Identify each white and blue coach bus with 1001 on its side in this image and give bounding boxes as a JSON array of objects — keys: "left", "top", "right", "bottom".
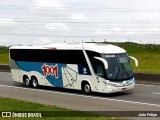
[{"left": 10, "top": 43, "right": 138, "bottom": 94}]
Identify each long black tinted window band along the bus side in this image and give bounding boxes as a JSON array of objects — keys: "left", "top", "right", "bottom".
[{"left": 10, "top": 49, "right": 88, "bottom": 67}]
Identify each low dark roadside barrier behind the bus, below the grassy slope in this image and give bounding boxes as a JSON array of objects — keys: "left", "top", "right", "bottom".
[{"left": 0, "top": 65, "right": 160, "bottom": 85}]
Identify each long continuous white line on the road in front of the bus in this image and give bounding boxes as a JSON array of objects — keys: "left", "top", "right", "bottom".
[{"left": 0, "top": 85, "right": 160, "bottom": 107}]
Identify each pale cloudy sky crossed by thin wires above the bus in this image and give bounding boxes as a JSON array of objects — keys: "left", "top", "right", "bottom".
[{"left": 0, "top": 0, "right": 160, "bottom": 46}]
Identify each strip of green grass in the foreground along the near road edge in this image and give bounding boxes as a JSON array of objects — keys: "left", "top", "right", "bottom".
[{"left": 0, "top": 98, "right": 119, "bottom": 120}]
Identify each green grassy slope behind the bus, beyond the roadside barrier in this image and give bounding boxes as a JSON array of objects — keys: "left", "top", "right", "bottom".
[{"left": 0, "top": 42, "right": 160, "bottom": 73}]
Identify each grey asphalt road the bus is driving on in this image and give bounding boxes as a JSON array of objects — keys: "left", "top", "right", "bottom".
[{"left": 0, "top": 72, "right": 160, "bottom": 120}]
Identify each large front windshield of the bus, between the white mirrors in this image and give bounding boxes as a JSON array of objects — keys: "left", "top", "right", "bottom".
[{"left": 102, "top": 53, "right": 133, "bottom": 81}]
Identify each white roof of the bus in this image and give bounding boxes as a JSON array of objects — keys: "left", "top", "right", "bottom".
[{"left": 10, "top": 43, "right": 126, "bottom": 54}]
